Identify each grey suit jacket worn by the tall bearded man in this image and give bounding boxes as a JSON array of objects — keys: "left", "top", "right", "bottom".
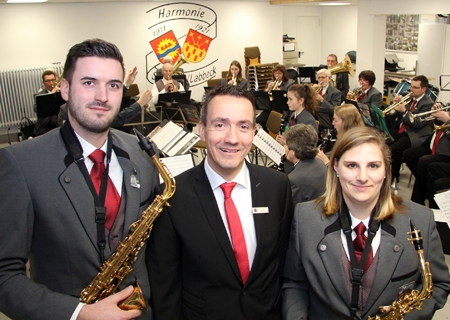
[{"left": 0, "top": 129, "right": 157, "bottom": 320}]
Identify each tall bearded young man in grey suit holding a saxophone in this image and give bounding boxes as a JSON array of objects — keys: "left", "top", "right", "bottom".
[{"left": 0, "top": 39, "right": 158, "bottom": 320}]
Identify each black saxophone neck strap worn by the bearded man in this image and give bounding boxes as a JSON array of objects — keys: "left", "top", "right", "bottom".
[{"left": 60, "top": 120, "right": 112, "bottom": 263}]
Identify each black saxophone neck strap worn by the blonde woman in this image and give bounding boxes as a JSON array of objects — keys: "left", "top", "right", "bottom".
[{"left": 339, "top": 201, "right": 380, "bottom": 320}]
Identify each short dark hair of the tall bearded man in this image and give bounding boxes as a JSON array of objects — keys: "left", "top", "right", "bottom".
[{"left": 63, "top": 39, "right": 125, "bottom": 83}]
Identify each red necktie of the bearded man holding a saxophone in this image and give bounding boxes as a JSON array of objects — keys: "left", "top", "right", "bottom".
[{"left": 89, "top": 149, "right": 120, "bottom": 230}]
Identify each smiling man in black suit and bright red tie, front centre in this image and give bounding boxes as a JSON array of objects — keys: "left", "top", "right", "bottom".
[{"left": 147, "top": 86, "right": 293, "bottom": 320}]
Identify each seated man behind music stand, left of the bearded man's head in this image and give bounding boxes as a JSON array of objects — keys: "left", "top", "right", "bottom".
[{"left": 33, "top": 69, "right": 59, "bottom": 136}]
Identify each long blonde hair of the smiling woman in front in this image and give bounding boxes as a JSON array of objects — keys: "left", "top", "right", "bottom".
[{"left": 316, "top": 127, "right": 404, "bottom": 221}]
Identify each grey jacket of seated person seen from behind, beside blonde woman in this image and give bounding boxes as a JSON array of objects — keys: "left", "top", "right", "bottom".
[{"left": 288, "top": 158, "right": 327, "bottom": 204}]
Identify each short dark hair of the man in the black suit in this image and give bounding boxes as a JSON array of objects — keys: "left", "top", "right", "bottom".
[{"left": 200, "top": 84, "right": 256, "bottom": 125}]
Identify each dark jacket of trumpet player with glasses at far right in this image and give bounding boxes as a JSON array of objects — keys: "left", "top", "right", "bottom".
[{"left": 398, "top": 95, "right": 434, "bottom": 147}]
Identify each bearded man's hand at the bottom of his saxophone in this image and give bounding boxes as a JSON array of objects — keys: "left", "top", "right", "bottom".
[{"left": 77, "top": 286, "right": 142, "bottom": 320}]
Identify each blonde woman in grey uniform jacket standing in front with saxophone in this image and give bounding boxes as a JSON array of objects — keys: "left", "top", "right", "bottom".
[{"left": 282, "top": 126, "right": 450, "bottom": 320}]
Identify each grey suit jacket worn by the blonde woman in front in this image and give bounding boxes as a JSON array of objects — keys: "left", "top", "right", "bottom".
[{"left": 283, "top": 201, "right": 450, "bottom": 320}]
